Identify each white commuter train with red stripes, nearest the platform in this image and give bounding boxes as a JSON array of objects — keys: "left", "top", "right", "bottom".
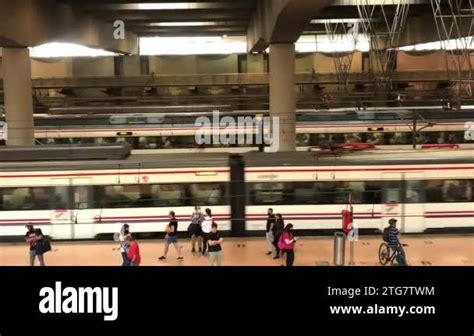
[{"left": 0, "top": 150, "right": 474, "bottom": 239}]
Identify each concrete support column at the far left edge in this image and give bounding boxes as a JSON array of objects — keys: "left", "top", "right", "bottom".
[{"left": 3, "top": 48, "right": 35, "bottom": 146}]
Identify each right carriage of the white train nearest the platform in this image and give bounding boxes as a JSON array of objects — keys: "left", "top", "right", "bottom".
[{"left": 246, "top": 151, "right": 474, "bottom": 232}]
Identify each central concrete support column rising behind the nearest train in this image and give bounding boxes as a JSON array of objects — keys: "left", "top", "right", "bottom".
[{"left": 270, "top": 43, "right": 296, "bottom": 152}]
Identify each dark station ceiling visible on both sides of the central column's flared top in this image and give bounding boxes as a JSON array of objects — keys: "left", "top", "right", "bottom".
[{"left": 61, "top": 0, "right": 438, "bottom": 36}]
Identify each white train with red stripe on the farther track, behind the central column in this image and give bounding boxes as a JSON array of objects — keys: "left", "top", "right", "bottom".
[{"left": 5, "top": 105, "right": 474, "bottom": 154}]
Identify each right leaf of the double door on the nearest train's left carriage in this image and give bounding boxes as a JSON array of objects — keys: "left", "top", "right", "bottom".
[{"left": 71, "top": 178, "right": 97, "bottom": 239}]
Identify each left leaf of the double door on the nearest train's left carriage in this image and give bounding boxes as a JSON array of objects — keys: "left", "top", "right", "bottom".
[{"left": 50, "top": 179, "right": 74, "bottom": 239}]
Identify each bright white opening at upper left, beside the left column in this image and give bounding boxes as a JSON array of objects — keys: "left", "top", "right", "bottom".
[{"left": 30, "top": 42, "right": 118, "bottom": 58}]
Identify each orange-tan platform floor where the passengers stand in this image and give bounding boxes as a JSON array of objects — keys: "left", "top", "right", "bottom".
[{"left": 0, "top": 234, "right": 474, "bottom": 266}]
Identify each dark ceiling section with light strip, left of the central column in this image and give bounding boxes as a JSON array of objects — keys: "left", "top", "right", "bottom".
[{"left": 63, "top": 0, "right": 257, "bottom": 37}]
